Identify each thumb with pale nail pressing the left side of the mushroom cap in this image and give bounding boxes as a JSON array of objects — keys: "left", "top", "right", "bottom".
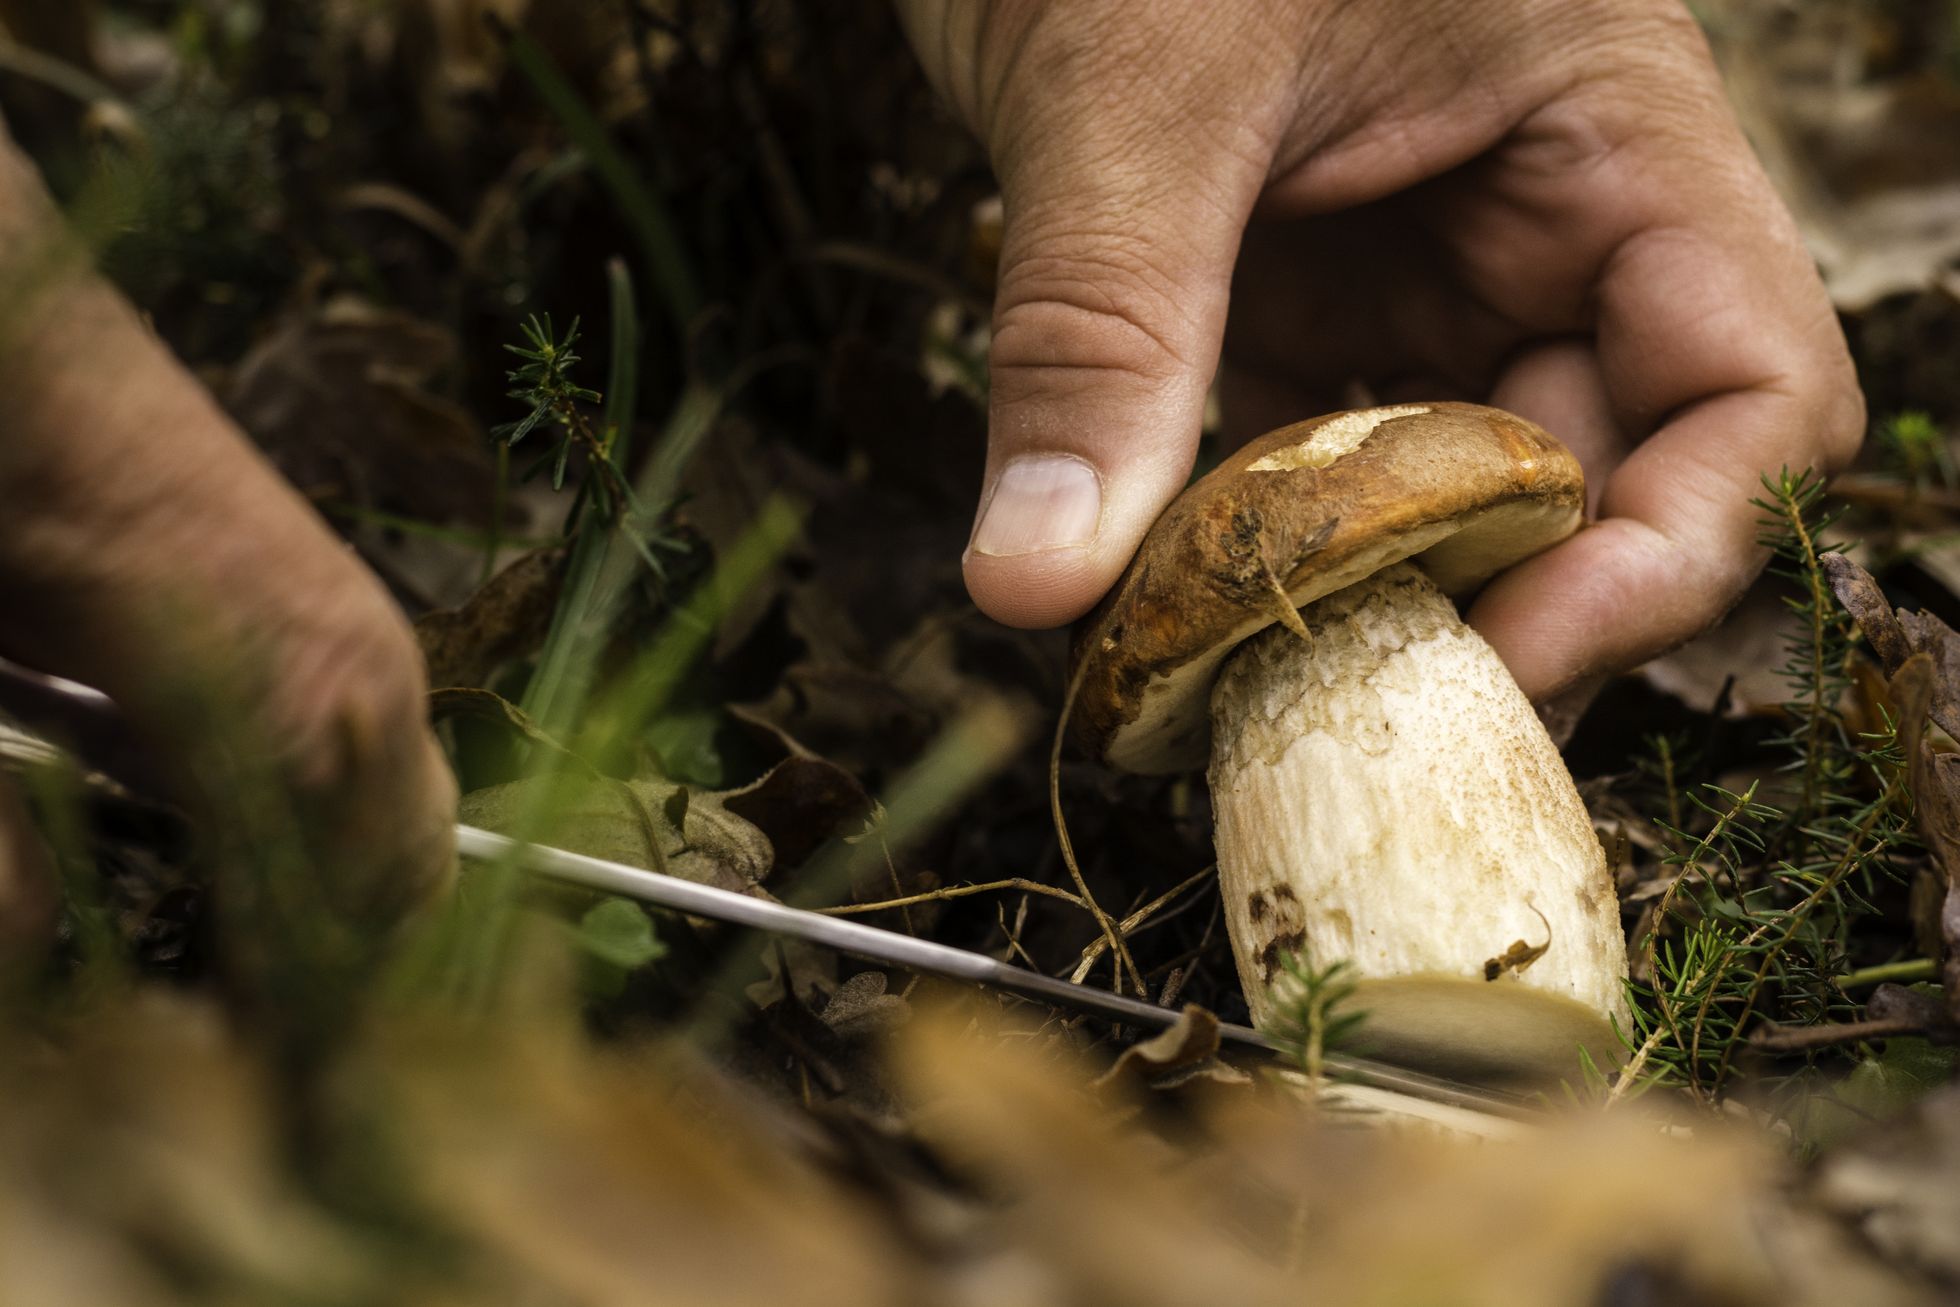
[{"left": 964, "top": 43, "right": 1270, "bottom": 627}]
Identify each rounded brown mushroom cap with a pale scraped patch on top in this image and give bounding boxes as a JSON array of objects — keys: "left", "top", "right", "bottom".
[{"left": 1070, "top": 404, "right": 1586, "bottom": 774}]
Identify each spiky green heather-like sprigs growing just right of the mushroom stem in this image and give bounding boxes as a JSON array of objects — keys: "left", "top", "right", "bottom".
[{"left": 1611, "top": 472, "right": 1917, "bottom": 1103}]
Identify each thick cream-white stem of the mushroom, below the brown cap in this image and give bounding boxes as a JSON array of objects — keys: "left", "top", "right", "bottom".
[{"left": 1211, "top": 564, "right": 1627, "bottom": 1066}]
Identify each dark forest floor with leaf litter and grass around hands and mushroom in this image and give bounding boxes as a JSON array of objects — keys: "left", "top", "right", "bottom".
[{"left": 0, "top": 0, "right": 1960, "bottom": 1307}]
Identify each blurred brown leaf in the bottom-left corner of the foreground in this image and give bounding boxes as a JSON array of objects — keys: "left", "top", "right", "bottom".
[{"left": 0, "top": 993, "right": 380, "bottom": 1307}]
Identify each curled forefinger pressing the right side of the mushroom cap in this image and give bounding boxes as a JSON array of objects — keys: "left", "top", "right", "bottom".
[{"left": 1470, "top": 12, "right": 1864, "bottom": 698}]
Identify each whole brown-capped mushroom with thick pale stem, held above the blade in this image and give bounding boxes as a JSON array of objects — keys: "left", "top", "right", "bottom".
[{"left": 1070, "top": 404, "right": 1627, "bottom": 1082}]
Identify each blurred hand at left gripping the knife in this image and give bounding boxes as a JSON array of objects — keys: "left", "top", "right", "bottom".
[{"left": 0, "top": 135, "right": 455, "bottom": 917}]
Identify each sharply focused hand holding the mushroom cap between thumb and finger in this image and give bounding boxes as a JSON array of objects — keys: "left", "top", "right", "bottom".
[{"left": 898, "top": 0, "right": 1864, "bottom": 700}]
